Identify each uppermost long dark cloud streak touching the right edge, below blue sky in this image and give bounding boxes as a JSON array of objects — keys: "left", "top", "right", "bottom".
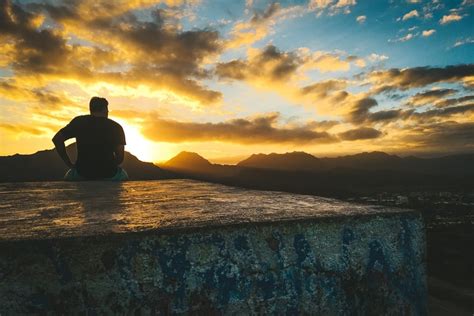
[{"left": 369, "top": 64, "right": 474, "bottom": 92}]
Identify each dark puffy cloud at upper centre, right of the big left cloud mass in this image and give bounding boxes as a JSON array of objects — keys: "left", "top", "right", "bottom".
[{"left": 216, "top": 45, "right": 301, "bottom": 81}]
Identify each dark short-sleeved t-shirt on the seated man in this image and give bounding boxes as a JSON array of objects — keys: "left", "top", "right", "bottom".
[{"left": 61, "top": 115, "right": 125, "bottom": 179}]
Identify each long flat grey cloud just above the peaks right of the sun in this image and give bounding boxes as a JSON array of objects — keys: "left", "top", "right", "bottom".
[{"left": 142, "top": 113, "right": 337, "bottom": 144}]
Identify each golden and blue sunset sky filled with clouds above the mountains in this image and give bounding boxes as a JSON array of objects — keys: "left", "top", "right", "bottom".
[{"left": 0, "top": 0, "right": 474, "bottom": 163}]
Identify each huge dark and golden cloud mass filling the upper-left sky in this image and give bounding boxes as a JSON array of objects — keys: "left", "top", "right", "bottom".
[{"left": 0, "top": 1, "right": 222, "bottom": 105}]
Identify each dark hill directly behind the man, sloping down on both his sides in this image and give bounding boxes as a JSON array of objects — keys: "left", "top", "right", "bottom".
[{"left": 0, "top": 143, "right": 176, "bottom": 182}]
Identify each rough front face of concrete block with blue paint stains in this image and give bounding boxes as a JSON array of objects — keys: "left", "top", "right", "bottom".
[{"left": 0, "top": 212, "right": 426, "bottom": 315}]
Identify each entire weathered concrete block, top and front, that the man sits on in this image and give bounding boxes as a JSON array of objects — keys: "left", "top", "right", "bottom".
[{"left": 0, "top": 180, "right": 426, "bottom": 315}]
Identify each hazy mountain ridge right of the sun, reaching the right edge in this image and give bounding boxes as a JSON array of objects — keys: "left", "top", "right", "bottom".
[{"left": 160, "top": 152, "right": 474, "bottom": 197}]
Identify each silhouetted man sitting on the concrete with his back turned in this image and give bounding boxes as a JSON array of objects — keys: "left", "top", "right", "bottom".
[{"left": 53, "top": 97, "right": 128, "bottom": 181}]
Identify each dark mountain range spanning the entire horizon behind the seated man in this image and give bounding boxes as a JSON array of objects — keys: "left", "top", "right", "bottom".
[{"left": 0, "top": 144, "right": 474, "bottom": 197}]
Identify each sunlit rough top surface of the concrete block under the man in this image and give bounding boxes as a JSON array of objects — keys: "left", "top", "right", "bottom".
[{"left": 0, "top": 180, "right": 412, "bottom": 241}]
